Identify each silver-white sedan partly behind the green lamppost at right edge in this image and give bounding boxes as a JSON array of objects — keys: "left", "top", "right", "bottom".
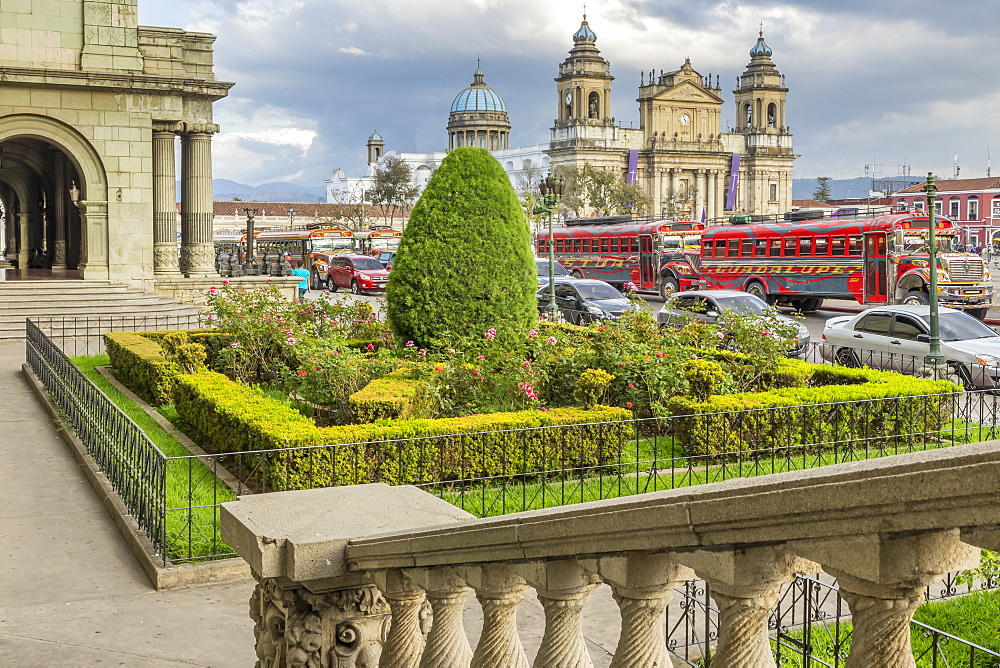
[{"left": 822, "top": 305, "right": 1000, "bottom": 390}]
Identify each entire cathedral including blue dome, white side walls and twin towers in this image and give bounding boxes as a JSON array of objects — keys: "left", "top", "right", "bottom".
[{"left": 327, "top": 15, "right": 797, "bottom": 220}]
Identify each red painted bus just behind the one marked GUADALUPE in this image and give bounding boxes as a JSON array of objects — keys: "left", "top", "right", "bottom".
[{"left": 536, "top": 216, "right": 705, "bottom": 298}]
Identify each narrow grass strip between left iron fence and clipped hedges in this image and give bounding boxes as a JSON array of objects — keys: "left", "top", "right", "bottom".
[{"left": 73, "top": 355, "right": 236, "bottom": 561}]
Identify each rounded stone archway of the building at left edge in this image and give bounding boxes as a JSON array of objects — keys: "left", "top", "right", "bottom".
[{"left": 0, "top": 114, "right": 109, "bottom": 280}]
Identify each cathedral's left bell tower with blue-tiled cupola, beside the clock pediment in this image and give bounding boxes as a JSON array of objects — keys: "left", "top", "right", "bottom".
[{"left": 556, "top": 14, "right": 614, "bottom": 126}]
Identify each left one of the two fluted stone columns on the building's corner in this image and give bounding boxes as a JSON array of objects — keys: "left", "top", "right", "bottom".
[{"left": 153, "top": 126, "right": 182, "bottom": 276}]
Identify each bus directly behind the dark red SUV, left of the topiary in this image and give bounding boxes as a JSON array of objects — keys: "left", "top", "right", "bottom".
[{"left": 254, "top": 227, "right": 354, "bottom": 290}]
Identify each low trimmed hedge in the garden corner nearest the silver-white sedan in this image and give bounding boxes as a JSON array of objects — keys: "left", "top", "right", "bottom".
[{"left": 659, "top": 365, "right": 960, "bottom": 455}]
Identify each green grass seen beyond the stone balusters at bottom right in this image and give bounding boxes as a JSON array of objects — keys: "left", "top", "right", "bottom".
[{"left": 771, "top": 591, "right": 1000, "bottom": 668}]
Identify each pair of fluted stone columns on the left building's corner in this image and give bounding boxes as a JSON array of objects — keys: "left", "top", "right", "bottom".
[{"left": 153, "top": 122, "right": 219, "bottom": 277}]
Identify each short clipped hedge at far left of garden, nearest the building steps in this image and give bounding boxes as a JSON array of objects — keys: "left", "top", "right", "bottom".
[{"left": 104, "top": 332, "right": 180, "bottom": 405}]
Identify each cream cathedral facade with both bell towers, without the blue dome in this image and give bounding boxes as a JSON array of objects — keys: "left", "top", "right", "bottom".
[{"left": 548, "top": 16, "right": 797, "bottom": 219}]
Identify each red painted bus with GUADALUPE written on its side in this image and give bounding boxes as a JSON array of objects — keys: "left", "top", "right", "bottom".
[{"left": 694, "top": 213, "right": 993, "bottom": 319}]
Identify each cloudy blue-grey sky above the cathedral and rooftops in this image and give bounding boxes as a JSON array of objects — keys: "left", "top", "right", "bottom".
[{"left": 139, "top": 0, "right": 1000, "bottom": 186}]
